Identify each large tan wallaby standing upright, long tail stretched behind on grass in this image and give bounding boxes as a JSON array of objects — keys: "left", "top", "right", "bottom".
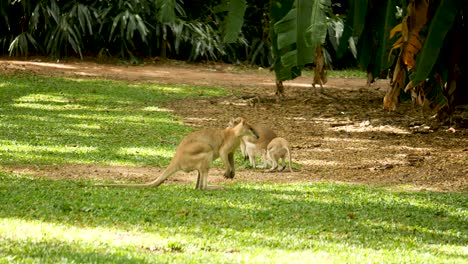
[{"left": 98, "top": 118, "right": 258, "bottom": 190}]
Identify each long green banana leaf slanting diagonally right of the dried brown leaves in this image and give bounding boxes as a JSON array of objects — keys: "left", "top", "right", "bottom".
[{"left": 410, "top": 0, "right": 466, "bottom": 86}]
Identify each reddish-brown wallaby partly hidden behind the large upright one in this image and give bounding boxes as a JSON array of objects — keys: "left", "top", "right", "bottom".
[{"left": 229, "top": 119, "right": 276, "bottom": 169}]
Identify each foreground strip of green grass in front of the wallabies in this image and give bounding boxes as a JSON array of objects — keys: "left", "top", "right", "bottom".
[{"left": 0, "top": 173, "right": 468, "bottom": 263}]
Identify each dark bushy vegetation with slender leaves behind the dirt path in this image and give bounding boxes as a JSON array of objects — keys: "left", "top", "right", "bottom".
[{"left": 0, "top": 0, "right": 356, "bottom": 68}]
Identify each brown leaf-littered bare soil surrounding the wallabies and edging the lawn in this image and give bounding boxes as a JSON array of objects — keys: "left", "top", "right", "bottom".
[{"left": 0, "top": 59, "right": 468, "bottom": 192}]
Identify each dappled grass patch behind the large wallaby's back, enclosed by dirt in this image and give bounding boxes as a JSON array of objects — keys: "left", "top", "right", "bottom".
[{"left": 0, "top": 74, "right": 226, "bottom": 166}]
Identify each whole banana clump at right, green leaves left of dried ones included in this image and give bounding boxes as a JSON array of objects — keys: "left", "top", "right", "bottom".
[{"left": 338, "top": 0, "right": 468, "bottom": 117}]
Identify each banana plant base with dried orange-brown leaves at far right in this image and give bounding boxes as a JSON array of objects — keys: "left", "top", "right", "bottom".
[{"left": 384, "top": 0, "right": 468, "bottom": 118}]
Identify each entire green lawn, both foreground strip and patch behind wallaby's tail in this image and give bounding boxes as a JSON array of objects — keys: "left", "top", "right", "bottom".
[{"left": 0, "top": 73, "right": 468, "bottom": 263}]
